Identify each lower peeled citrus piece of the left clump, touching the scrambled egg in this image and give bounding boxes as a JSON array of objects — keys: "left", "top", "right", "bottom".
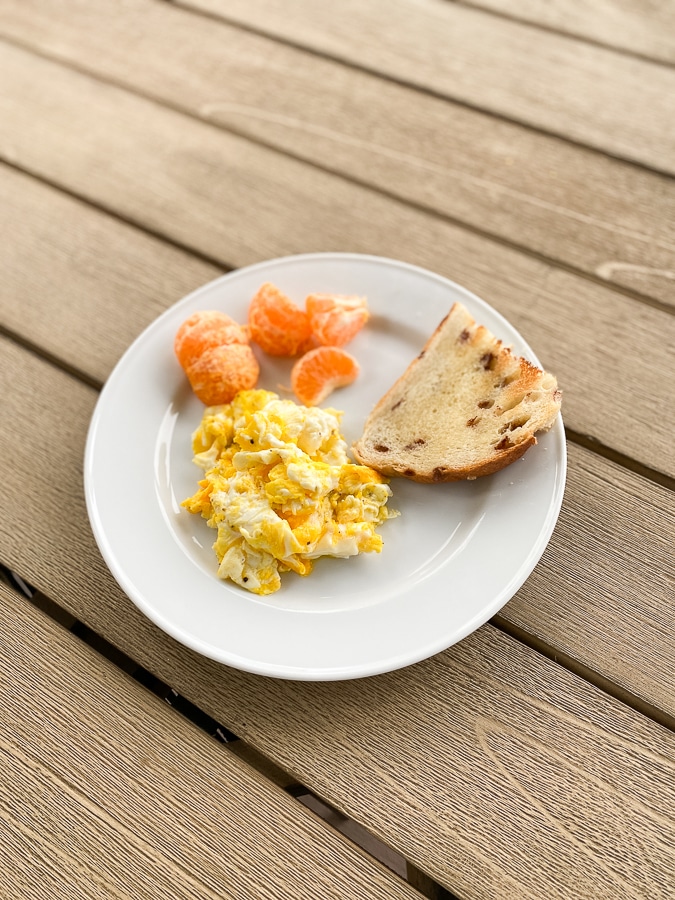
[{"left": 185, "top": 344, "right": 260, "bottom": 406}]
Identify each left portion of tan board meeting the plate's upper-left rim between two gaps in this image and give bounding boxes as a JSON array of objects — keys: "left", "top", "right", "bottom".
[{"left": 0, "top": 165, "right": 223, "bottom": 383}]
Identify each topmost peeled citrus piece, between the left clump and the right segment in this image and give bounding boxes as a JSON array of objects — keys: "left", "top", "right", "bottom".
[{"left": 248, "top": 282, "right": 312, "bottom": 356}]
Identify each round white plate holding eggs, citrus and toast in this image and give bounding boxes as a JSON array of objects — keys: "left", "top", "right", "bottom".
[{"left": 84, "top": 253, "right": 566, "bottom": 680}]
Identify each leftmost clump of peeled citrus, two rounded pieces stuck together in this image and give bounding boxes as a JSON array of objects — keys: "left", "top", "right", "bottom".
[{"left": 174, "top": 310, "right": 260, "bottom": 406}]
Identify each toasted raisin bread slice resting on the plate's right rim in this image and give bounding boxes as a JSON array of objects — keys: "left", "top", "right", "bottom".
[{"left": 352, "top": 303, "right": 561, "bottom": 482}]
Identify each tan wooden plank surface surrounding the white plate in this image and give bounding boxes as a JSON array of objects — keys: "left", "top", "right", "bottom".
[{"left": 0, "top": 0, "right": 675, "bottom": 900}]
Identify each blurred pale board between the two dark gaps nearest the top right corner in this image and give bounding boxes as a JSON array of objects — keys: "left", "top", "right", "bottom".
[{"left": 172, "top": 0, "right": 675, "bottom": 174}]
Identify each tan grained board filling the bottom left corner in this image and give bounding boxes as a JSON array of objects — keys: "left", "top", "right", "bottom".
[{"left": 0, "top": 585, "right": 420, "bottom": 900}]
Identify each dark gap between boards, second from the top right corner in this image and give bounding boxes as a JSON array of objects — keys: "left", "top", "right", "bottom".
[{"left": 165, "top": 0, "right": 674, "bottom": 178}]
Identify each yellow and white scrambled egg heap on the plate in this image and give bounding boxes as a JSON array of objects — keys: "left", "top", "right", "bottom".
[{"left": 183, "top": 390, "right": 398, "bottom": 594}]
